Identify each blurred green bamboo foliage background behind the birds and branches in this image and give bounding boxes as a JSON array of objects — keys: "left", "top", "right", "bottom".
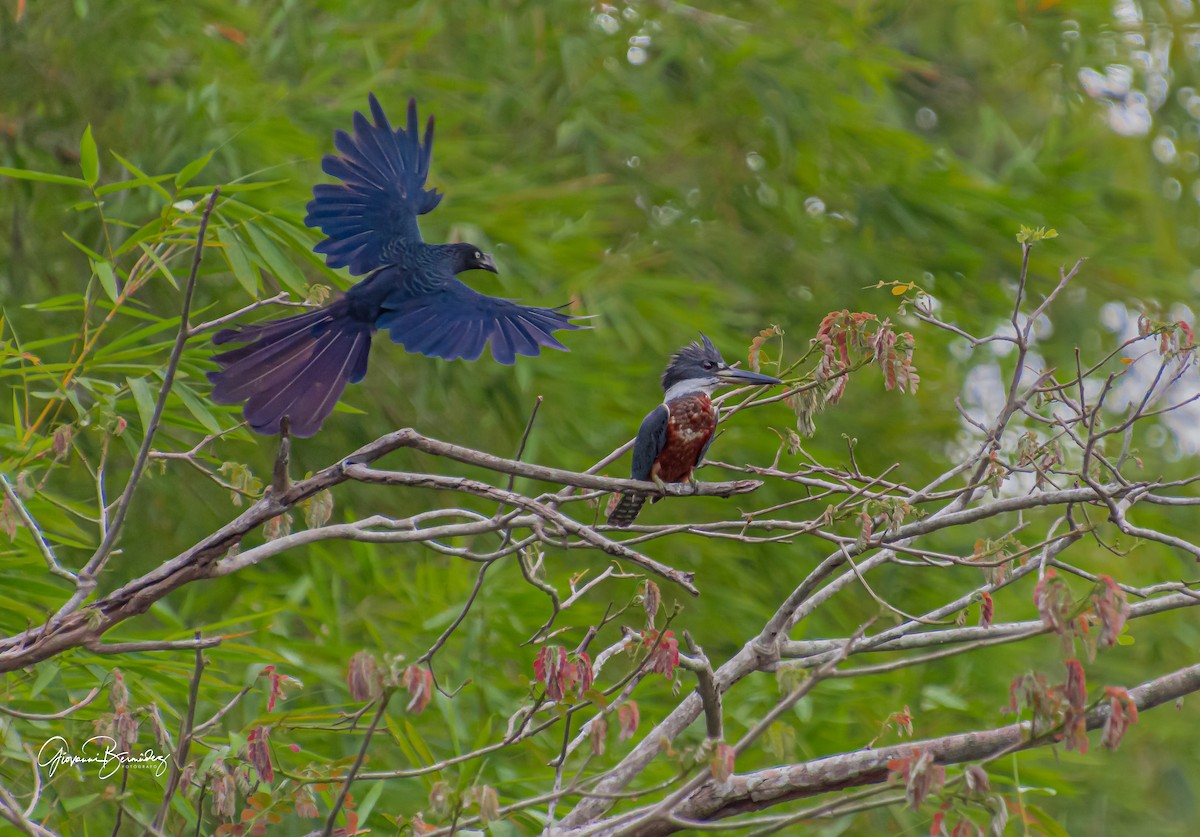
[{"left": 0, "top": 0, "right": 1200, "bottom": 835}]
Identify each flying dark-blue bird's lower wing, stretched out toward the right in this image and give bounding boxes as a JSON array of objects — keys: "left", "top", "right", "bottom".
[{"left": 376, "top": 279, "right": 583, "bottom": 363}]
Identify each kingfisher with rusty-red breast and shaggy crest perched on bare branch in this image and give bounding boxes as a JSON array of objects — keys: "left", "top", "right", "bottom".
[{"left": 608, "top": 332, "right": 784, "bottom": 526}]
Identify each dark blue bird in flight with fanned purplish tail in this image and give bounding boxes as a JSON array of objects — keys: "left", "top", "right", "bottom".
[{"left": 209, "top": 94, "right": 581, "bottom": 436}]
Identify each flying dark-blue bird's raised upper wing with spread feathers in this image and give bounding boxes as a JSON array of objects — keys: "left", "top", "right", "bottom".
[{"left": 304, "top": 94, "right": 442, "bottom": 276}]
